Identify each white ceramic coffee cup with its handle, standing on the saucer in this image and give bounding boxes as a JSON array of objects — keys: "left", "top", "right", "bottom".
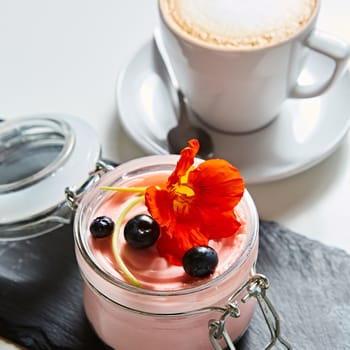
[{"left": 159, "top": 0, "right": 350, "bottom": 133}]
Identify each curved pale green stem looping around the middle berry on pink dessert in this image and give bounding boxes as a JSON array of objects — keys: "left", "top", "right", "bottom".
[{"left": 112, "top": 196, "right": 144, "bottom": 287}]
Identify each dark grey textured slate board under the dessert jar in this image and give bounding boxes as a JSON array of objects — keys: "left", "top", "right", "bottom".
[{"left": 0, "top": 222, "right": 350, "bottom": 350}]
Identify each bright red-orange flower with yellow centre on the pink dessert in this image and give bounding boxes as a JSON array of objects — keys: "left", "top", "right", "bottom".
[{"left": 145, "top": 140, "right": 244, "bottom": 265}]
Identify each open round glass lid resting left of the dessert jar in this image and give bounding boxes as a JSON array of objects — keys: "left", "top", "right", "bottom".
[{"left": 0, "top": 114, "right": 100, "bottom": 240}]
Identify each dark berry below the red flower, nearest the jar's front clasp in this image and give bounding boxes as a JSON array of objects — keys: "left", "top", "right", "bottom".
[{"left": 182, "top": 246, "right": 219, "bottom": 277}]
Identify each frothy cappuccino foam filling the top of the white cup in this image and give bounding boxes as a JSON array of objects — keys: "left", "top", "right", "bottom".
[{"left": 160, "top": 0, "right": 318, "bottom": 48}]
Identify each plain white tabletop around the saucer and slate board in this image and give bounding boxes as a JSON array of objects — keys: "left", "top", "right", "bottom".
[{"left": 0, "top": 0, "right": 350, "bottom": 349}]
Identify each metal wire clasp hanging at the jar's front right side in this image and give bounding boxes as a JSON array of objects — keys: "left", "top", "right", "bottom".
[{"left": 208, "top": 274, "right": 292, "bottom": 350}]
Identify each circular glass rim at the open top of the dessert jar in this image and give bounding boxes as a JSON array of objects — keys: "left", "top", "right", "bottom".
[{"left": 74, "top": 155, "right": 259, "bottom": 296}]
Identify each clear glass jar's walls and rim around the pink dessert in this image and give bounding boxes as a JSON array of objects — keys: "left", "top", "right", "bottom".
[{"left": 74, "top": 155, "right": 259, "bottom": 350}]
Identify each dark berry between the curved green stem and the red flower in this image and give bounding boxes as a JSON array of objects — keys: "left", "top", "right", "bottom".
[{"left": 124, "top": 214, "right": 160, "bottom": 249}]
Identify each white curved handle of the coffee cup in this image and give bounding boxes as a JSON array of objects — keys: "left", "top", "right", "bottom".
[{"left": 290, "top": 30, "right": 350, "bottom": 98}]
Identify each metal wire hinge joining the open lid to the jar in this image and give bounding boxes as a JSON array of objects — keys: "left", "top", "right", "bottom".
[{"left": 64, "top": 160, "right": 114, "bottom": 210}]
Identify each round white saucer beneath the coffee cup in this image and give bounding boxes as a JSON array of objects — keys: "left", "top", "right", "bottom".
[{"left": 116, "top": 41, "right": 350, "bottom": 184}]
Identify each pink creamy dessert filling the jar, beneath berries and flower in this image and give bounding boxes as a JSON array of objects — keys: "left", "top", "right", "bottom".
[{"left": 74, "top": 155, "right": 258, "bottom": 350}]
